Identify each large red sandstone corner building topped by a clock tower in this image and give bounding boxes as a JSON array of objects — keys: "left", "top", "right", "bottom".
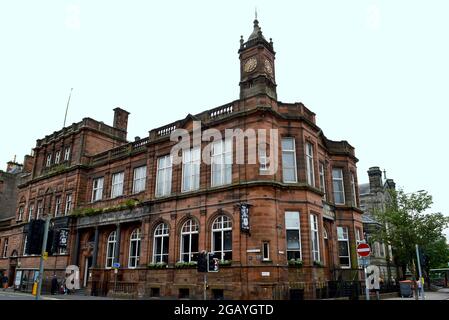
[{"left": 0, "top": 20, "right": 363, "bottom": 299}]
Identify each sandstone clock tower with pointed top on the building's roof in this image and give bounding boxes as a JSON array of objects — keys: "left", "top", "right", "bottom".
[{"left": 239, "top": 18, "right": 277, "bottom": 100}]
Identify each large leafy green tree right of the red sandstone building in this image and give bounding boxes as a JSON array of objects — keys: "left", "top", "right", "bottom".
[{"left": 373, "top": 190, "right": 449, "bottom": 282}]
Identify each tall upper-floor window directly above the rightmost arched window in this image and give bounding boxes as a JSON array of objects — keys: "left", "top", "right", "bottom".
[{"left": 211, "top": 139, "right": 232, "bottom": 187}]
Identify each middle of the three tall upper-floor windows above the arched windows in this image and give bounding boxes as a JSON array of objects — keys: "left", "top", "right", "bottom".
[{"left": 182, "top": 147, "right": 201, "bottom": 192}]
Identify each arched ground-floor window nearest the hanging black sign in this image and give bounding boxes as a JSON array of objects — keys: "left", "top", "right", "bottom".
[{"left": 212, "top": 216, "right": 232, "bottom": 260}]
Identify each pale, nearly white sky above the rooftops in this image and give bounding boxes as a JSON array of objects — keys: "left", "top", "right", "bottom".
[{"left": 0, "top": 0, "right": 449, "bottom": 239}]
